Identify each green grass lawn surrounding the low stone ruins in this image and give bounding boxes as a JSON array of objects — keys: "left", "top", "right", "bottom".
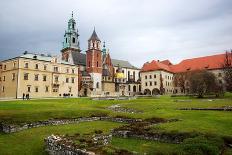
[{"left": 0, "top": 95, "right": 232, "bottom": 154}]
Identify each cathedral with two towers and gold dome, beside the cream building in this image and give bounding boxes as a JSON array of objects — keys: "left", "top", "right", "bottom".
[{"left": 61, "top": 15, "right": 141, "bottom": 96}]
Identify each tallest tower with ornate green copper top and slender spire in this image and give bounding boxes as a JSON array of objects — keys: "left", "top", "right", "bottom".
[{"left": 61, "top": 12, "right": 81, "bottom": 61}]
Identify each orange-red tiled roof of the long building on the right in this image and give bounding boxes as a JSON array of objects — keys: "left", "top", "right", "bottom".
[{"left": 142, "top": 54, "right": 225, "bottom": 73}]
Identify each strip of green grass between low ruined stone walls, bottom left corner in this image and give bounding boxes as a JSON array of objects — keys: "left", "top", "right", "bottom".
[{"left": 0, "top": 121, "right": 121, "bottom": 155}]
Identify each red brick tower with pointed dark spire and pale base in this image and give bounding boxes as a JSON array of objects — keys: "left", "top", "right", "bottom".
[{"left": 86, "top": 29, "right": 102, "bottom": 91}]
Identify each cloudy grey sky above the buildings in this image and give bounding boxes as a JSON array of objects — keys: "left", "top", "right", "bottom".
[{"left": 0, "top": 0, "right": 232, "bottom": 67}]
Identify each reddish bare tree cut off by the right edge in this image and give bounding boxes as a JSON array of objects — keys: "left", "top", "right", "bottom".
[{"left": 223, "top": 50, "right": 232, "bottom": 92}]
